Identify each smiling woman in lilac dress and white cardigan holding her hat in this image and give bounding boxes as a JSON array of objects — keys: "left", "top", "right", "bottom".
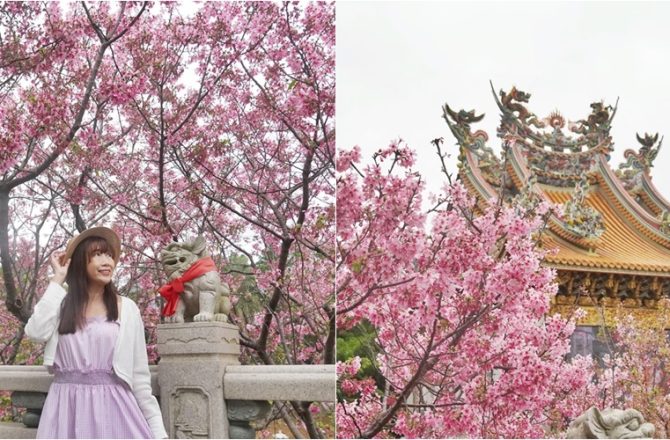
[{"left": 25, "top": 227, "right": 167, "bottom": 438}]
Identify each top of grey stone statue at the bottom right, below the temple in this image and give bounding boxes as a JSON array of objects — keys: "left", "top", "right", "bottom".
[{"left": 566, "top": 406, "right": 655, "bottom": 438}]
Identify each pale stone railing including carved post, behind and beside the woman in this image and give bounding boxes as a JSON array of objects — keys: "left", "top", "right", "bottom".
[{"left": 0, "top": 322, "right": 336, "bottom": 438}]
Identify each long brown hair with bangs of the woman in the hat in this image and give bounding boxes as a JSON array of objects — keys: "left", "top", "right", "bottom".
[{"left": 58, "top": 237, "right": 119, "bottom": 335}]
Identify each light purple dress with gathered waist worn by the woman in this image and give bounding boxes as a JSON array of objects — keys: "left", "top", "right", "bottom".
[{"left": 37, "top": 316, "right": 152, "bottom": 438}]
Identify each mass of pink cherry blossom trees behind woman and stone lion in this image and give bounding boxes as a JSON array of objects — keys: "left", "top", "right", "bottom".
[{"left": 0, "top": 3, "right": 335, "bottom": 437}]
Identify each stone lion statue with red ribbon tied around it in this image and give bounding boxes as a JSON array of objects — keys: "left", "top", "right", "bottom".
[{"left": 160, "top": 236, "right": 230, "bottom": 323}]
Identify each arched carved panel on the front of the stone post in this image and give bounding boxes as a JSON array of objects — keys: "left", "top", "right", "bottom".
[{"left": 171, "top": 388, "right": 209, "bottom": 438}]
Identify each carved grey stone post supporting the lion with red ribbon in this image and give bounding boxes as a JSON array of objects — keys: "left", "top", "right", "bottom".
[{"left": 157, "top": 321, "right": 240, "bottom": 438}]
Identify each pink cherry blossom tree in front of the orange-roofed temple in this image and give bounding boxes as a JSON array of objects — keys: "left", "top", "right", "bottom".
[{"left": 336, "top": 141, "right": 592, "bottom": 438}]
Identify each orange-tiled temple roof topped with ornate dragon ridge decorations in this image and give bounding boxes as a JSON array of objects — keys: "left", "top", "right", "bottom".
[{"left": 444, "top": 85, "right": 670, "bottom": 277}]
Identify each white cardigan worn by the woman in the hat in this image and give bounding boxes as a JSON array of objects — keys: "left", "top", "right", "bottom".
[{"left": 25, "top": 282, "right": 167, "bottom": 438}]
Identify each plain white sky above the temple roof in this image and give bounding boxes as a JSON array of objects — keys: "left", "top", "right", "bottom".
[{"left": 337, "top": 2, "right": 670, "bottom": 200}]
